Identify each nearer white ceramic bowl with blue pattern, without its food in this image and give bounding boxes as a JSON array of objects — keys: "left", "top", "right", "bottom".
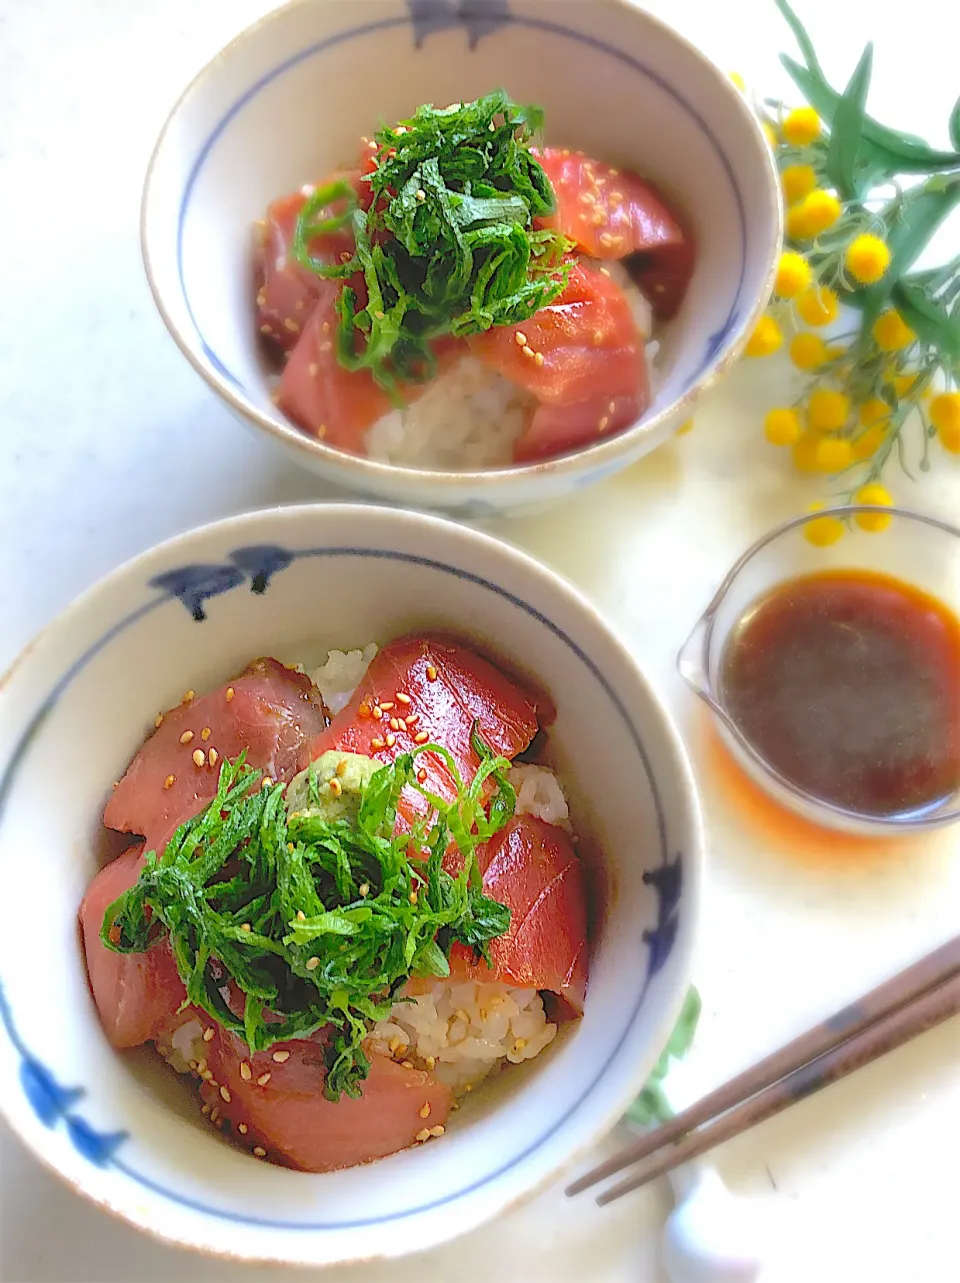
[{"left": 0, "top": 506, "right": 702, "bottom": 1264}]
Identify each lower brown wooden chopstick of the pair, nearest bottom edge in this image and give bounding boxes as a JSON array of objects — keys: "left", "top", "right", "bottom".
[{"left": 597, "top": 976, "right": 960, "bottom": 1207}]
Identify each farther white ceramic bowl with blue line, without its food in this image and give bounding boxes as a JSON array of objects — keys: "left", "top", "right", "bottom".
[{"left": 142, "top": 0, "right": 780, "bottom": 516}]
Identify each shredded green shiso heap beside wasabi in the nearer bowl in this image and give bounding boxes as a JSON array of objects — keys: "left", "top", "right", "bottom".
[{"left": 100, "top": 730, "right": 516, "bottom": 1101}]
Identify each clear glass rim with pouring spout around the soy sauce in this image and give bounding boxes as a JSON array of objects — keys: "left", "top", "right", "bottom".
[{"left": 676, "top": 503, "right": 960, "bottom": 838}]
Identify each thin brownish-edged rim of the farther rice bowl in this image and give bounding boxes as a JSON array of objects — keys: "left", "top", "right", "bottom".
[{"left": 140, "top": 0, "right": 783, "bottom": 487}]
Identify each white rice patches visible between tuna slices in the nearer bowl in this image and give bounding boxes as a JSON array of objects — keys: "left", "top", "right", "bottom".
[{"left": 164, "top": 643, "right": 569, "bottom": 1096}]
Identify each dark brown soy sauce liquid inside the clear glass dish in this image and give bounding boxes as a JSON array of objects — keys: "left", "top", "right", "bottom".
[{"left": 720, "top": 570, "right": 960, "bottom": 816}]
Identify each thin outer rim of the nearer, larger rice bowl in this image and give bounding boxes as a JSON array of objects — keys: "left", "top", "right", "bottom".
[{"left": 0, "top": 500, "right": 706, "bottom": 1268}]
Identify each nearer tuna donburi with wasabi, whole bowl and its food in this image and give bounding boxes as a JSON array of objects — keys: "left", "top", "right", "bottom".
[{"left": 0, "top": 504, "right": 702, "bottom": 1264}]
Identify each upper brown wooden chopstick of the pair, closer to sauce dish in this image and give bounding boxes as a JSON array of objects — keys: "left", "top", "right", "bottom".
[{"left": 567, "top": 935, "right": 960, "bottom": 1196}]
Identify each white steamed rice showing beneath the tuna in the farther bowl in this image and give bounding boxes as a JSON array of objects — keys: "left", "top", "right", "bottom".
[{"left": 366, "top": 268, "right": 660, "bottom": 472}]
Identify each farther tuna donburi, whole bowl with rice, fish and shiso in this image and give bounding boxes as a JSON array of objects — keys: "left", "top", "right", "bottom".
[{"left": 142, "top": 0, "right": 780, "bottom": 514}]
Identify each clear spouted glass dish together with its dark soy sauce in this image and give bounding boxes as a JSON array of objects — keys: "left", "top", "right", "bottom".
[{"left": 678, "top": 504, "right": 960, "bottom": 835}]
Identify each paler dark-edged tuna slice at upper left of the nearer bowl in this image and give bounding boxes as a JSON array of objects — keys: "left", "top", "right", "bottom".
[{"left": 104, "top": 659, "right": 327, "bottom": 851}]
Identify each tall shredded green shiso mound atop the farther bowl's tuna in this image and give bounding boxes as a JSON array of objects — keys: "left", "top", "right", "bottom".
[{"left": 294, "top": 90, "right": 571, "bottom": 404}]
